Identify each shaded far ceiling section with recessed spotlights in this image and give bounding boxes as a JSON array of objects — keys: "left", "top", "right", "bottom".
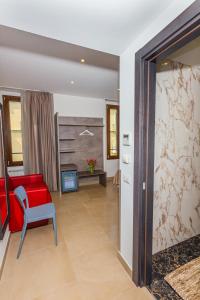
[{"left": 0, "top": 26, "right": 119, "bottom": 100}]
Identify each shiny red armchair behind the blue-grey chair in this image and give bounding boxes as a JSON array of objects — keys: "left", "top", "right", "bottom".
[{"left": 9, "top": 174, "right": 52, "bottom": 232}]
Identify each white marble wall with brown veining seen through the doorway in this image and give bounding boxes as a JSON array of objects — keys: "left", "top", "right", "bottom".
[{"left": 153, "top": 62, "right": 200, "bottom": 253}]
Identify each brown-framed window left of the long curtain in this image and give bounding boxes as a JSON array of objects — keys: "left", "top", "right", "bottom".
[{"left": 3, "top": 96, "right": 23, "bottom": 166}]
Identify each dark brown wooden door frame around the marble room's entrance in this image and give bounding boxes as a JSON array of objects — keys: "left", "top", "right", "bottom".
[{"left": 133, "top": 0, "right": 200, "bottom": 286}]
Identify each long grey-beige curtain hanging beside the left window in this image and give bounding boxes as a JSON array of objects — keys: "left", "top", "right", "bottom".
[{"left": 22, "top": 91, "right": 57, "bottom": 191}]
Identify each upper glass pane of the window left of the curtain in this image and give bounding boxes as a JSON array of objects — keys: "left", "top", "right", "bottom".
[{"left": 9, "top": 101, "right": 21, "bottom": 130}]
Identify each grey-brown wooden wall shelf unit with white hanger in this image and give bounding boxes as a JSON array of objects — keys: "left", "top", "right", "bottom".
[{"left": 55, "top": 113, "right": 105, "bottom": 195}]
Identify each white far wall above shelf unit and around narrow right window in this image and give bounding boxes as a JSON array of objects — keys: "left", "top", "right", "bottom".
[{"left": 54, "top": 94, "right": 119, "bottom": 177}]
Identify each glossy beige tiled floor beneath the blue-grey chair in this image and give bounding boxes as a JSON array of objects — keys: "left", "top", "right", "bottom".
[{"left": 0, "top": 184, "right": 152, "bottom": 300}]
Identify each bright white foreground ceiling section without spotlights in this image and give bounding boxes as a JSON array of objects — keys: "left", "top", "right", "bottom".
[{"left": 0, "top": 0, "right": 175, "bottom": 55}]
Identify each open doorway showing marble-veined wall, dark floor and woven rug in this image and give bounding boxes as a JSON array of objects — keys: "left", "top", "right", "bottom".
[{"left": 150, "top": 37, "right": 200, "bottom": 299}]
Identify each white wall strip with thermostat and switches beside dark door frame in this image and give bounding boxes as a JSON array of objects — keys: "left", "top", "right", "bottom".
[{"left": 120, "top": 0, "right": 194, "bottom": 268}]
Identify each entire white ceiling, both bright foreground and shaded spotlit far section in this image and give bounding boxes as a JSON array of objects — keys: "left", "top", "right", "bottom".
[{"left": 0, "top": 0, "right": 175, "bottom": 100}]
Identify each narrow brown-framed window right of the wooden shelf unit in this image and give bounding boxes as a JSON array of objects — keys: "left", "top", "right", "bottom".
[{"left": 107, "top": 105, "right": 119, "bottom": 159}]
